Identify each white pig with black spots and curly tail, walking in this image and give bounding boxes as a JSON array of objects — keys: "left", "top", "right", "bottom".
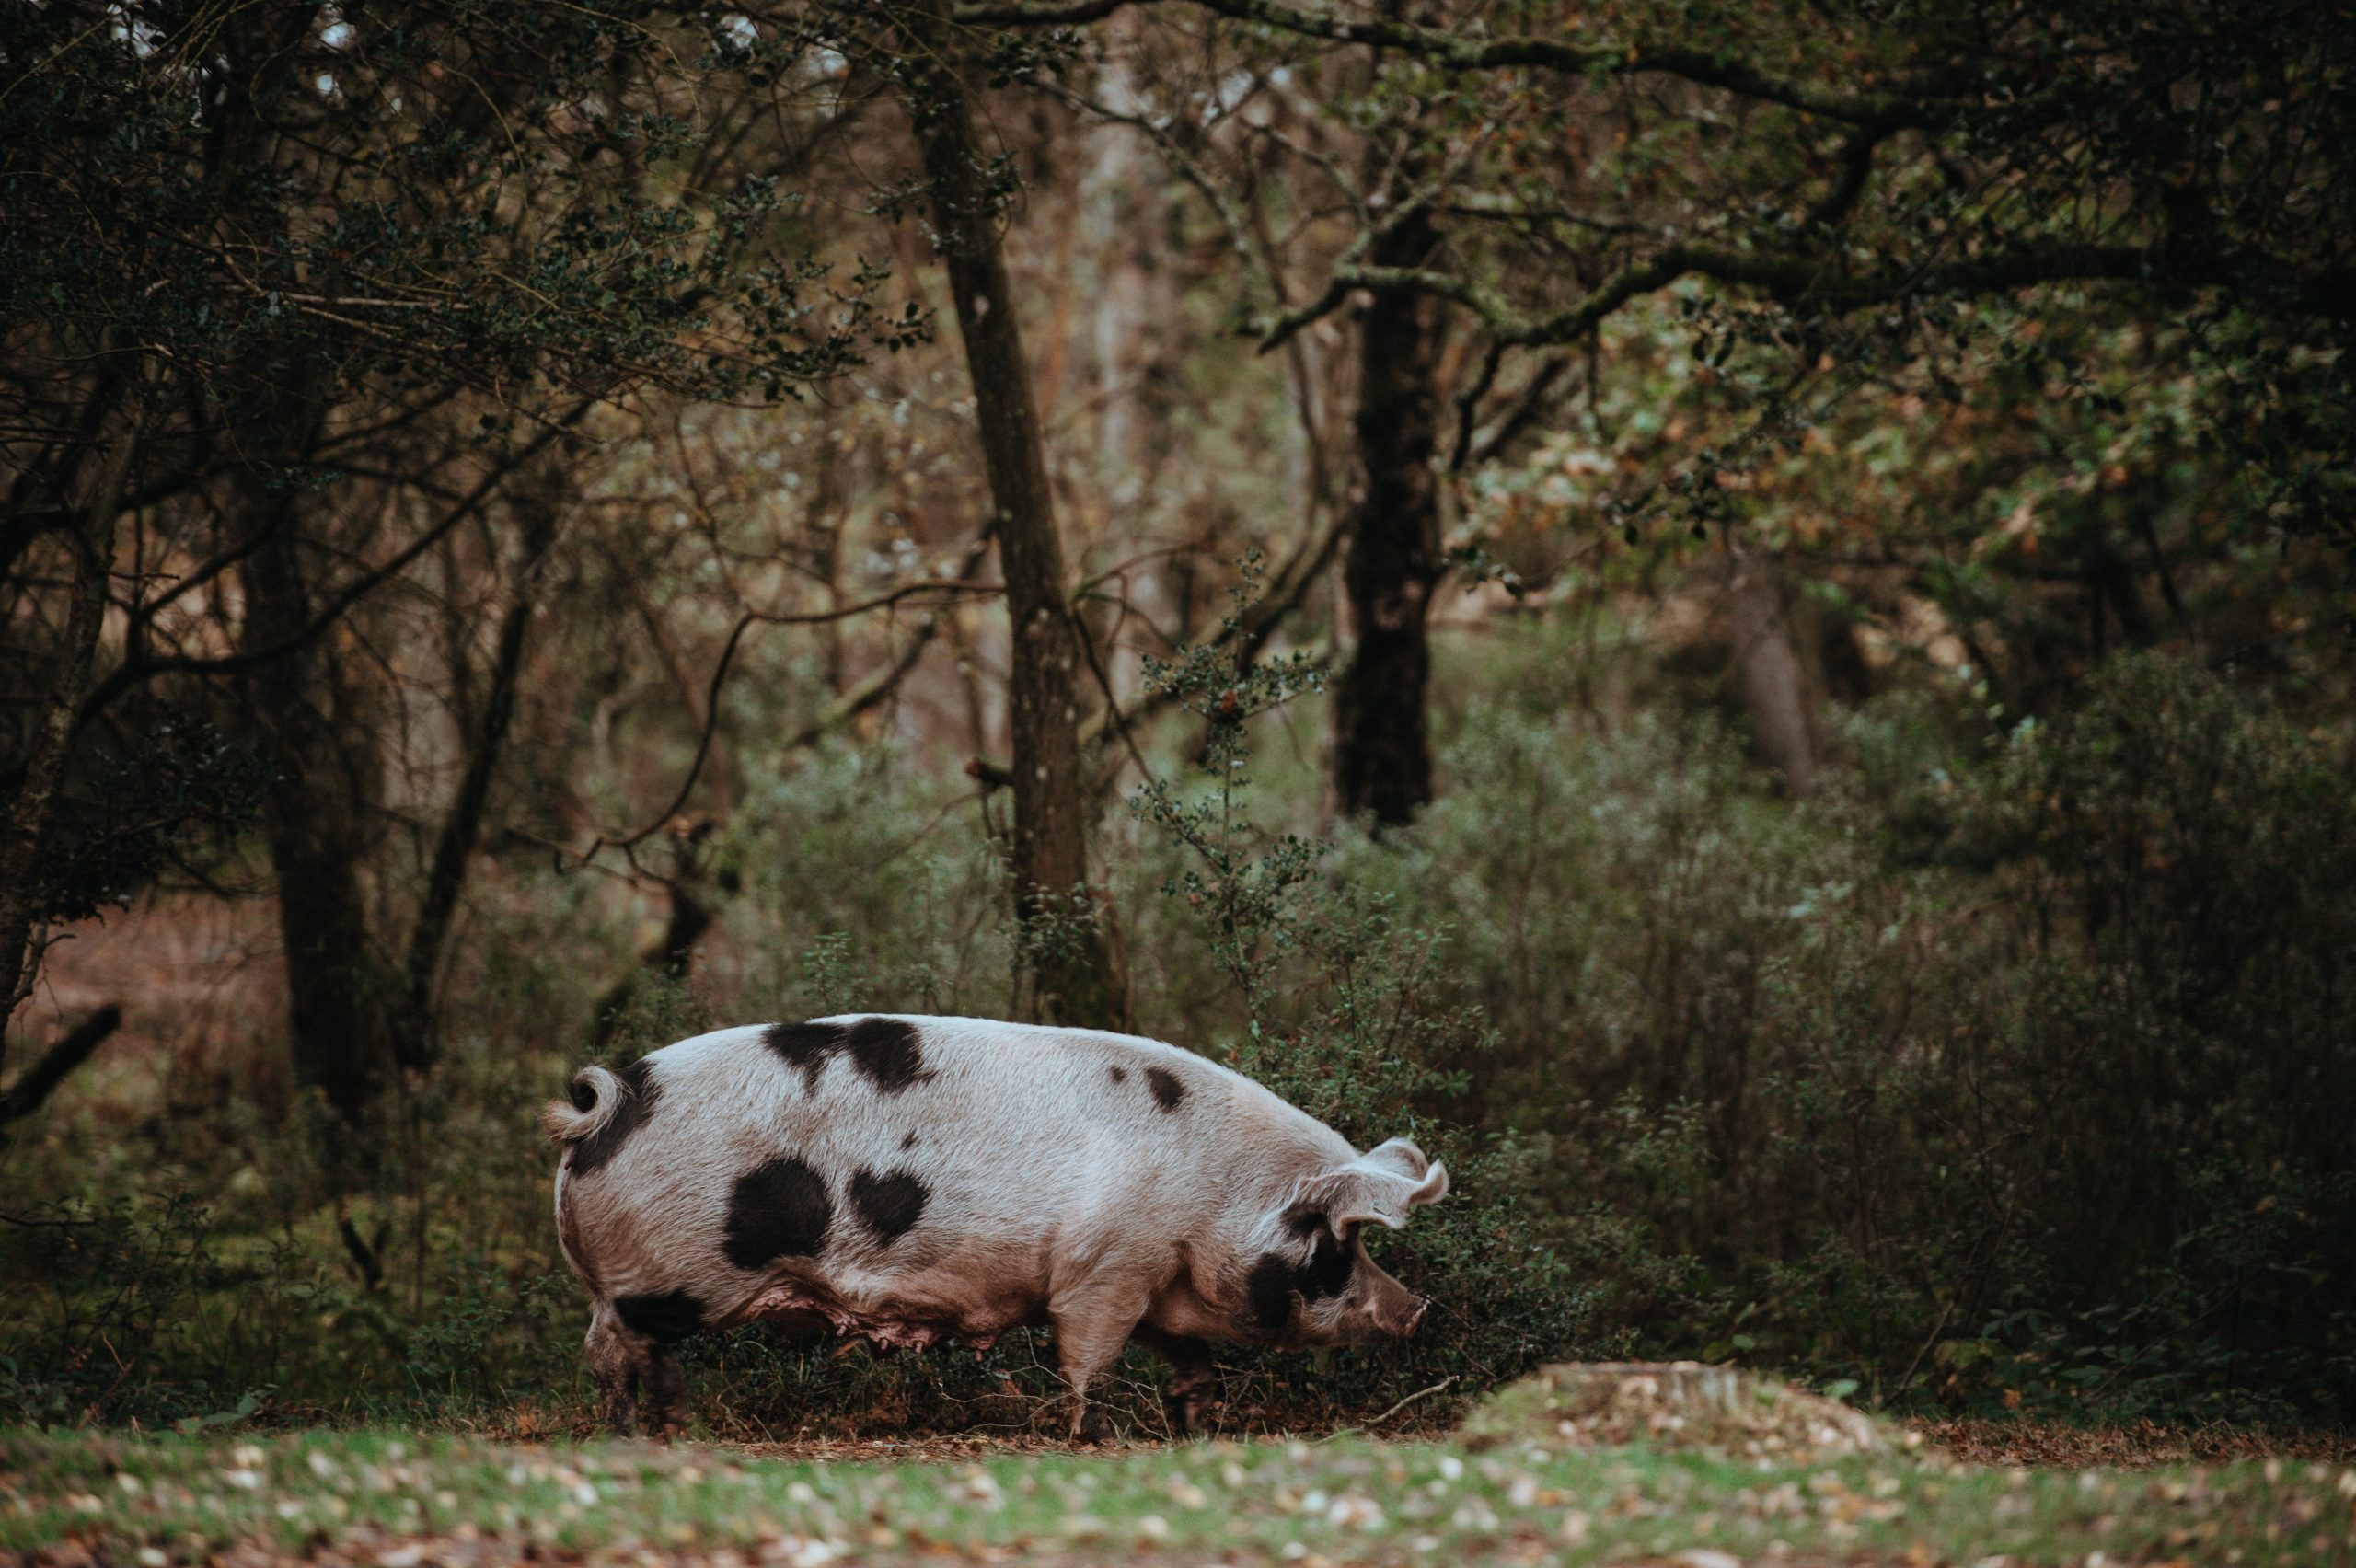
[{"left": 542, "top": 1015, "right": 1449, "bottom": 1443}]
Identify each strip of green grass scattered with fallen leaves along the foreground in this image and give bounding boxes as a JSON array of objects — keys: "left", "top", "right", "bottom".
[{"left": 0, "top": 1429, "right": 2356, "bottom": 1568}]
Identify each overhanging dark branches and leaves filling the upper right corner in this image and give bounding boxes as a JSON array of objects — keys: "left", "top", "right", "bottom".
[{"left": 954, "top": 0, "right": 2356, "bottom": 796}]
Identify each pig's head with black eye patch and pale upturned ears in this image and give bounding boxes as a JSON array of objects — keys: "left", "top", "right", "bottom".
[{"left": 1237, "top": 1137, "right": 1449, "bottom": 1349}]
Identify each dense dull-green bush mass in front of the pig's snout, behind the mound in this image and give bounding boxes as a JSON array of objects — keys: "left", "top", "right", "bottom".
[{"left": 1345, "top": 659, "right": 2356, "bottom": 1417}]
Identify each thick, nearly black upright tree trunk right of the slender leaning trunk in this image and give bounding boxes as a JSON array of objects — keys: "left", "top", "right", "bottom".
[{"left": 1334, "top": 201, "right": 1447, "bottom": 826}]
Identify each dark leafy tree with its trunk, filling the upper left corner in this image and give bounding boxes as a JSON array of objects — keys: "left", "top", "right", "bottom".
[{"left": 0, "top": 3, "right": 907, "bottom": 1116}]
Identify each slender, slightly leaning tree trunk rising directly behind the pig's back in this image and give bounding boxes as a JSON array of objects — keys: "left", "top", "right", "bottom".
[{"left": 909, "top": 17, "right": 1128, "bottom": 1029}]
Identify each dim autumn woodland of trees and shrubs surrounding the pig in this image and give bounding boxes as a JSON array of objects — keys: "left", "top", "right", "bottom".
[{"left": 0, "top": 0, "right": 2356, "bottom": 1561}]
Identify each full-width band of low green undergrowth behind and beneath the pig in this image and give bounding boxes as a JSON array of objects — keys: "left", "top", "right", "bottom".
[{"left": 0, "top": 635, "right": 2356, "bottom": 1436}]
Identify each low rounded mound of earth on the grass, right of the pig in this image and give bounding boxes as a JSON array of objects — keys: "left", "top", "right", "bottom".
[{"left": 1463, "top": 1361, "right": 1920, "bottom": 1464}]
